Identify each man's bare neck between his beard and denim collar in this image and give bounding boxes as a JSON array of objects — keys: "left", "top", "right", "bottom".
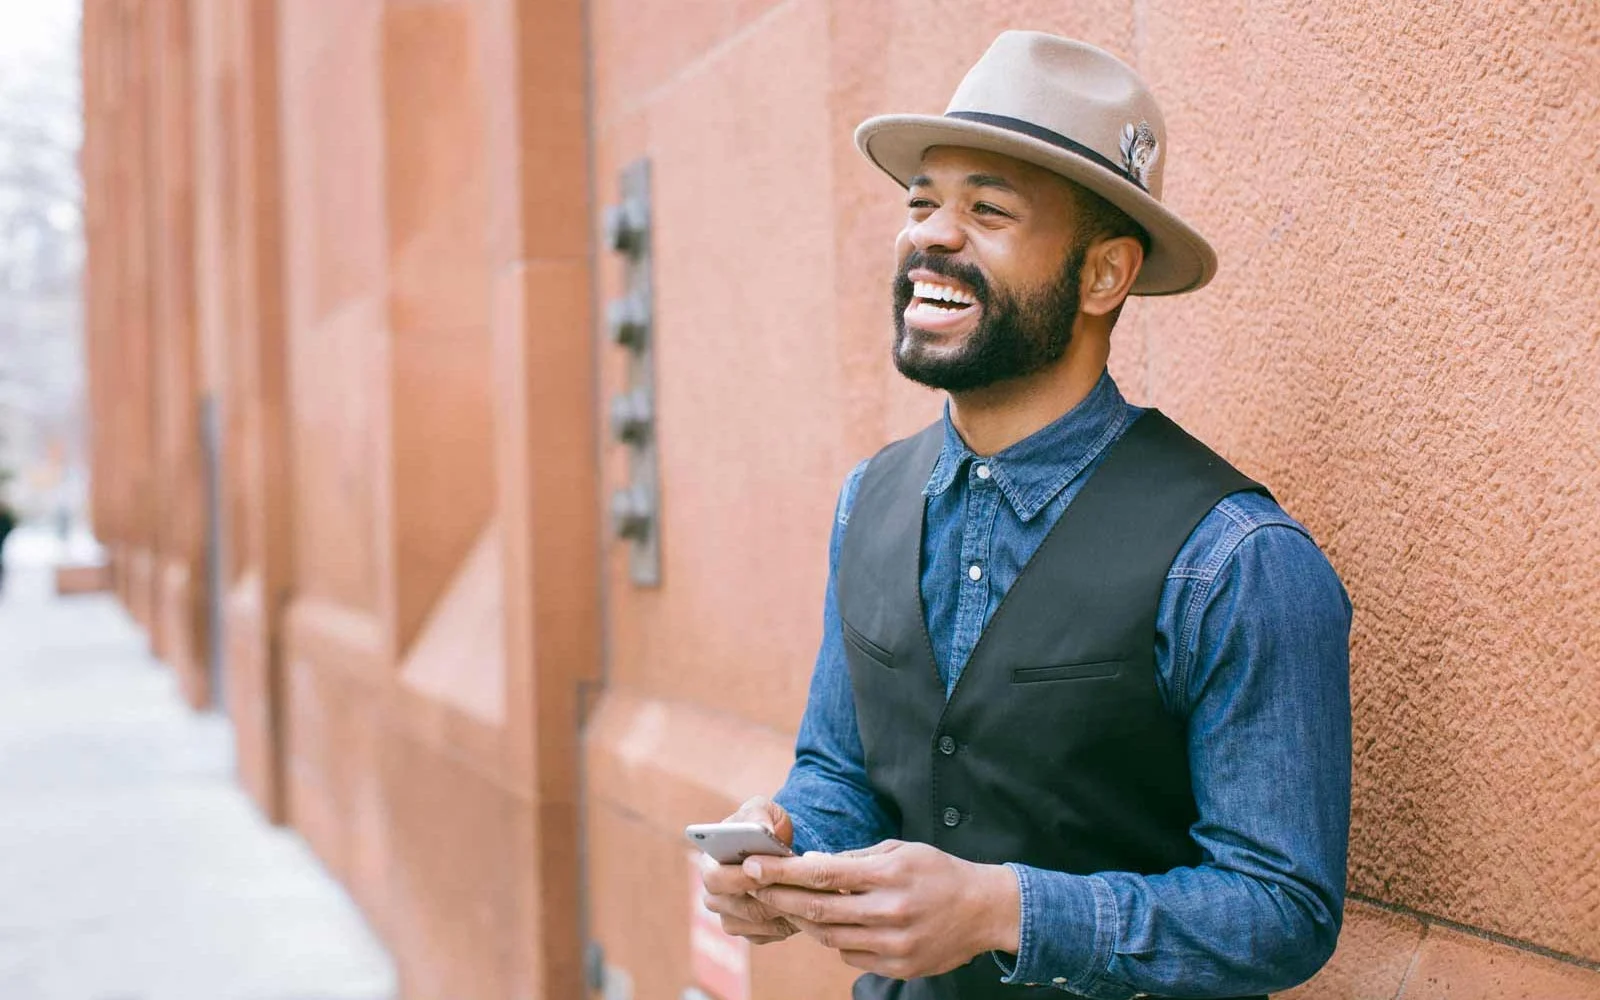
[{"left": 950, "top": 323, "right": 1110, "bottom": 454}]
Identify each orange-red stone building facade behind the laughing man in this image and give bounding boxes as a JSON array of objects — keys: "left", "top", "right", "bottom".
[{"left": 83, "top": 0, "right": 1600, "bottom": 1000}]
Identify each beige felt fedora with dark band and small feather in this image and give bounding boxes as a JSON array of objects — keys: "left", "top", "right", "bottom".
[{"left": 856, "top": 32, "right": 1216, "bottom": 294}]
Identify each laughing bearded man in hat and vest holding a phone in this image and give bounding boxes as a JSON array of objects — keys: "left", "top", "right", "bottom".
[{"left": 704, "top": 32, "right": 1350, "bottom": 1000}]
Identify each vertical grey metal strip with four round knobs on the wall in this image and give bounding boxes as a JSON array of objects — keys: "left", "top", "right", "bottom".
[{"left": 605, "top": 160, "right": 661, "bottom": 587}]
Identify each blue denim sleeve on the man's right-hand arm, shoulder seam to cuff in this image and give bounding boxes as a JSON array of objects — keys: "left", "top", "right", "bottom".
[{"left": 997, "top": 518, "right": 1350, "bottom": 1000}]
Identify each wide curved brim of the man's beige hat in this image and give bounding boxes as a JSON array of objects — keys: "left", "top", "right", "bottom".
[{"left": 856, "top": 115, "right": 1216, "bottom": 294}]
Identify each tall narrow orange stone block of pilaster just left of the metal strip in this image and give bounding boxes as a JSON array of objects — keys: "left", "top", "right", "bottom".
[{"left": 491, "top": 259, "right": 602, "bottom": 805}]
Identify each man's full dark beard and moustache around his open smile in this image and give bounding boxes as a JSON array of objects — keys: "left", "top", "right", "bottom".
[{"left": 894, "top": 246, "right": 1086, "bottom": 392}]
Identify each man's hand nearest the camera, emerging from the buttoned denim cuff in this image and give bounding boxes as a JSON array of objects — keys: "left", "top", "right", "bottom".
[{"left": 744, "top": 840, "right": 1021, "bottom": 979}]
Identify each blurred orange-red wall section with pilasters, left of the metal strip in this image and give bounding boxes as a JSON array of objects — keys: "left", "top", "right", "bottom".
[{"left": 85, "top": 0, "right": 600, "bottom": 1000}]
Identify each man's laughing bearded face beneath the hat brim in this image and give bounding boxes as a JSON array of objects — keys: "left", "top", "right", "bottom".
[{"left": 894, "top": 146, "right": 1085, "bottom": 392}]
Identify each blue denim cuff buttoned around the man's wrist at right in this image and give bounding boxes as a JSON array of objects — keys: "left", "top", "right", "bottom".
[{"left": 992, "top": 864, "right": 1134, "bottom": 1000}]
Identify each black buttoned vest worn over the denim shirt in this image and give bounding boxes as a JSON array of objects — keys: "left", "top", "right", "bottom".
[{"left": 838, "top": 410, "right": 1264, "bottom": 1000}]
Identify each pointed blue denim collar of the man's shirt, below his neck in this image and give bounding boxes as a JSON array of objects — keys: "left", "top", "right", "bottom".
[{"left": 923, "top": 371, "right": 1128, "bottom": 522}]
